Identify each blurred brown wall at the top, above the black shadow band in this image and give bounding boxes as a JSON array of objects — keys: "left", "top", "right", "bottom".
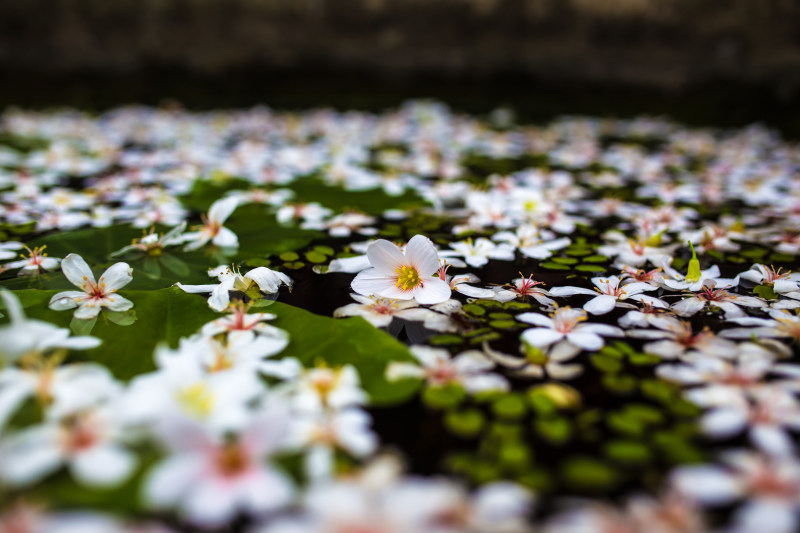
[{"left": 0, "top": 0, "right": 800, "bottom": 93}]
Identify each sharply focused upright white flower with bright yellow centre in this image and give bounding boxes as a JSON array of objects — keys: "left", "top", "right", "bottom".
[{"left": 352, "top": 235, "right": 450, "bottom": 305}]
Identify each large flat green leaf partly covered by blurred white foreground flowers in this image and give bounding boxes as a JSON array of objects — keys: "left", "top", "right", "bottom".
[{"left": 3, "top": 287, "right": 418, "bottom": 405}]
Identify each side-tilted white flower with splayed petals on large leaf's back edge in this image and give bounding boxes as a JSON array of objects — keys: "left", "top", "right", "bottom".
[{"left": 175, "top": 265, "right": 292, "bottom": 311}]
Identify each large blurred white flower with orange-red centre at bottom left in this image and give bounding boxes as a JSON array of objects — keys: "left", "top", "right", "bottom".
[{"left": 143, "top": 405, "right": 293, "bottom": 527}]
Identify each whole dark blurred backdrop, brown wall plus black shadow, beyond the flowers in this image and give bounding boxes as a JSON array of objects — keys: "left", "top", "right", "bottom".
[{"left": 0, "top": 0, "right": 800, "bottom": 138}]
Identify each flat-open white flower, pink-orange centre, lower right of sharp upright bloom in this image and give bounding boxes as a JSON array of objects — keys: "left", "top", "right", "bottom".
[{"left": 517, "top": 307, "right": 623, "bottom": 351}]
